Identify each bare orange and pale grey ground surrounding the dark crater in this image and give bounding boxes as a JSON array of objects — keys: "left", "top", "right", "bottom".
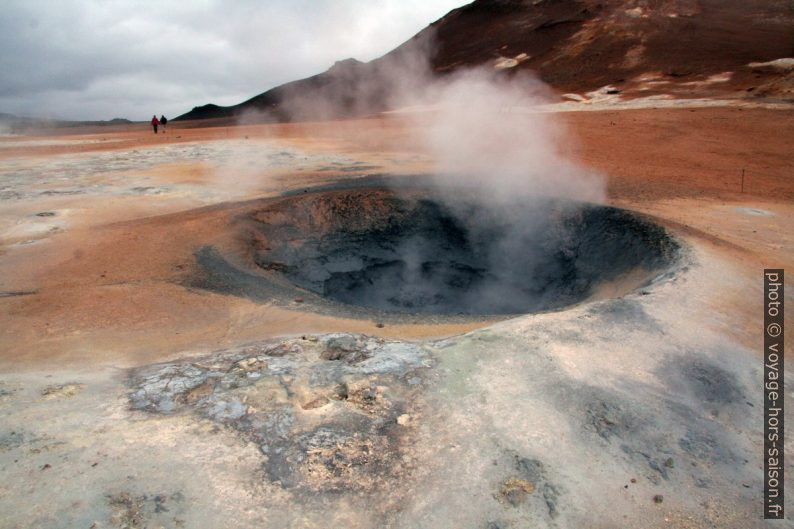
[{"left": 0, "top": 107, "right": 794, "bottom": 528}]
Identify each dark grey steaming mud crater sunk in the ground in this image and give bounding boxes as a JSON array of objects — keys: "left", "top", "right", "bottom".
[{"left": 250, "top": 188, "right": 678, "bottom": 315}]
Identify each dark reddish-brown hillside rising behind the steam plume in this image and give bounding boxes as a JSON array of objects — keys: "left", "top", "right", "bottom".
[{"left": 176, "top": 0, "right": 794, "bottom": 121}]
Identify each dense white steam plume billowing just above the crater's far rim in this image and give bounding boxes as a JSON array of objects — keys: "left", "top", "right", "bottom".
[{"left": 418, "top": 68, "right": 605, "bottom": 202}]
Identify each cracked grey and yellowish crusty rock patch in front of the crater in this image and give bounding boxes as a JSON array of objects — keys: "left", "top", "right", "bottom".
[{"left": 129, "top": 333, "right": 430, "bottom": 492}]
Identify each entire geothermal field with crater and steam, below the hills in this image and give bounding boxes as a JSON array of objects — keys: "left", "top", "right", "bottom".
[{"left": 0, "top": 2, "right": 794, "bottom": 529}]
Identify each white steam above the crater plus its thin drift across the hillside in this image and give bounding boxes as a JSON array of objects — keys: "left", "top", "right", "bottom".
[{"left": 232, "top": 32, "right": 605, "bottom": 202}]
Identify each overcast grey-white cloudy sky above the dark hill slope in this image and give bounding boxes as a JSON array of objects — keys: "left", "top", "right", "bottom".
[{"left": 0, "top": 0, "right": 460, "bottom": 120}]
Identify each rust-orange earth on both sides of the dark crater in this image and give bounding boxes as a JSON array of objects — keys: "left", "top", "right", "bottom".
[{"left": 0, "top": 107, "right": 794, "bottom": 369}]
